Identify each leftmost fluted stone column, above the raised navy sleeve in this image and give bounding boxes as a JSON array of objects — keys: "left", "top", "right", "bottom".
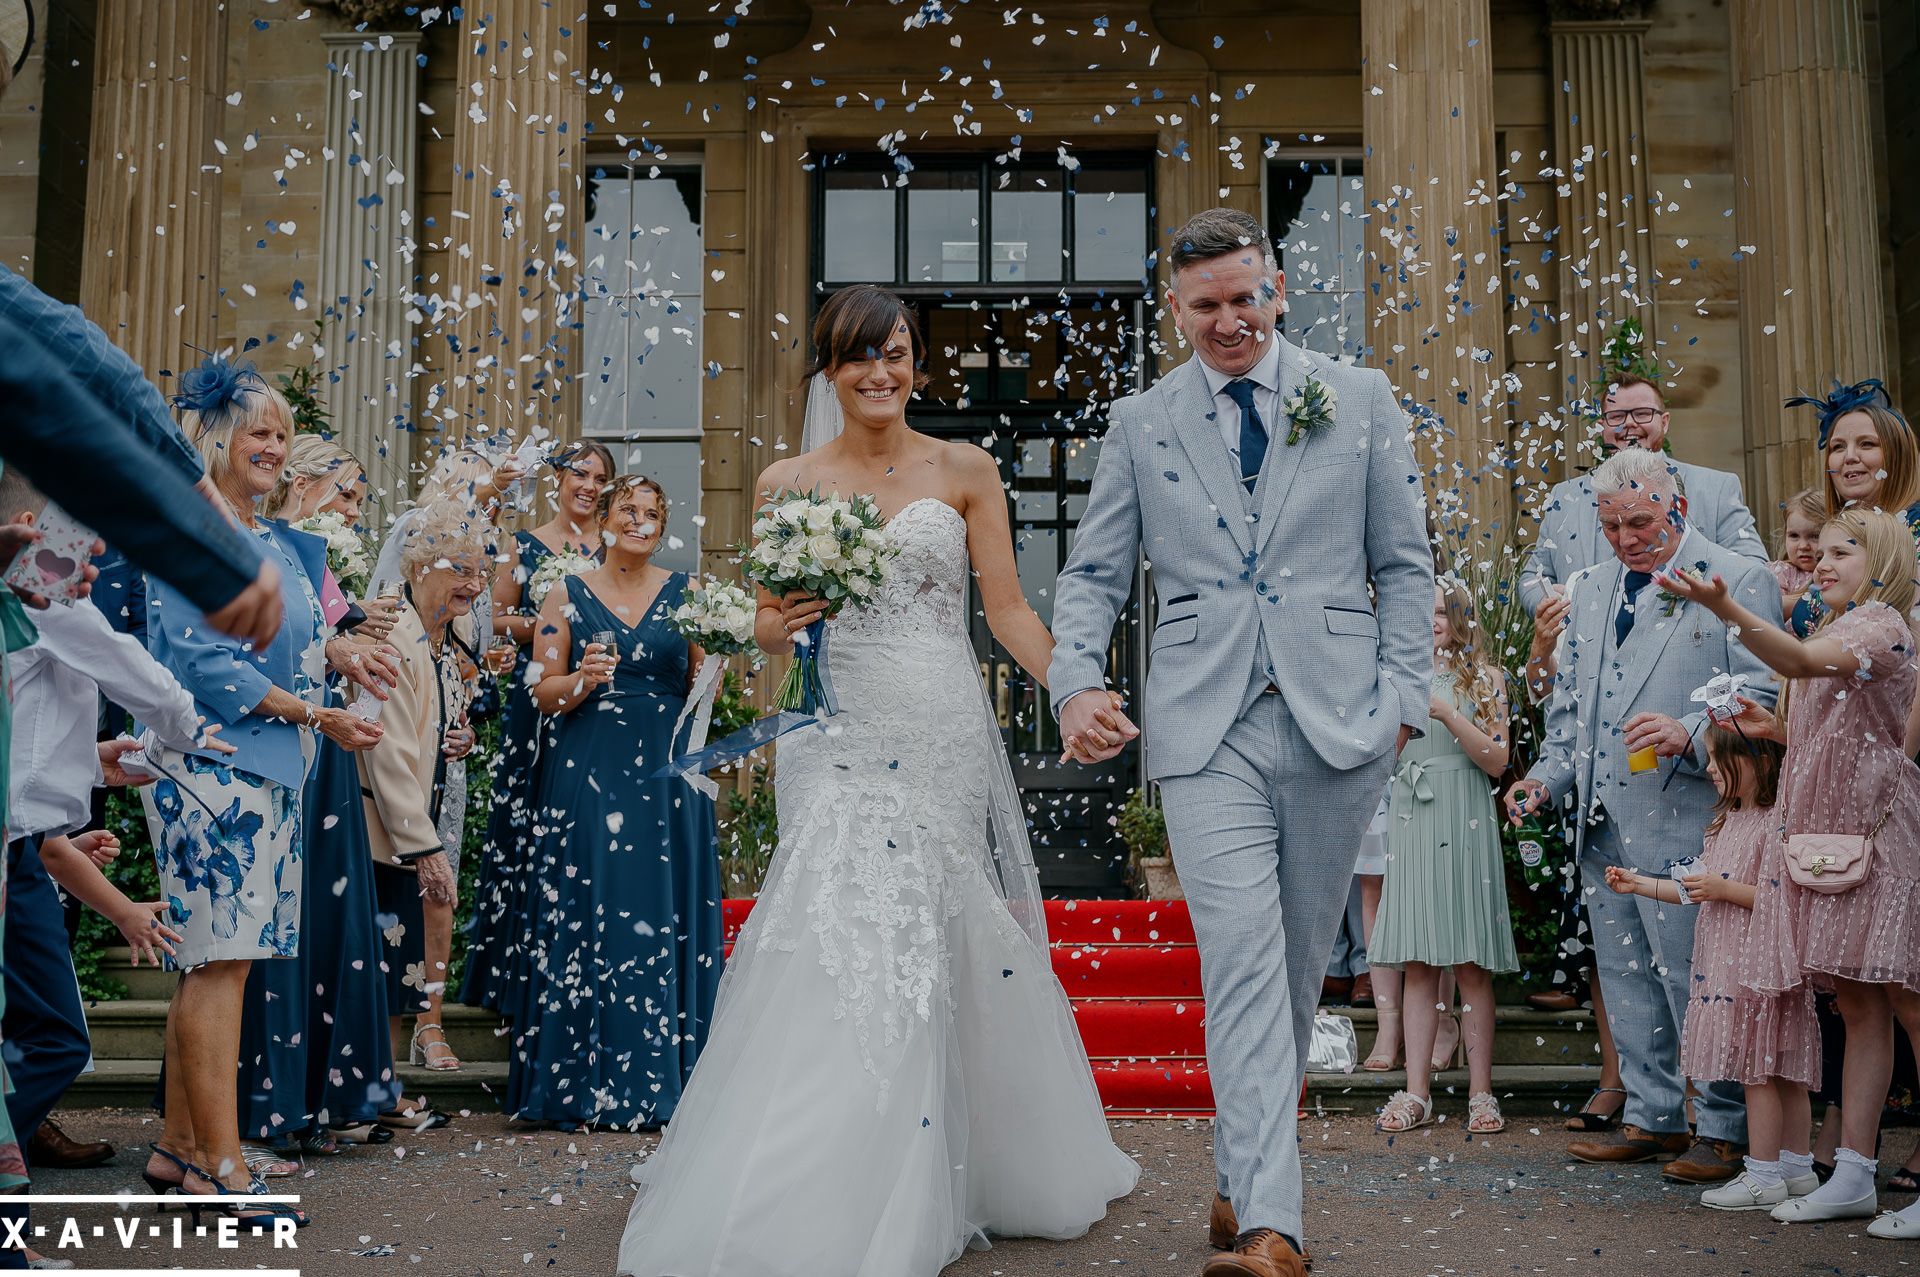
[{"left": 81, "top": 0, "right": 227, "bottom": 388}]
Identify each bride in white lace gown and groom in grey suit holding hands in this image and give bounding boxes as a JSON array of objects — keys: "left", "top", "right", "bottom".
[{"left": 618, "top": 209, "right": 1432, "bottom": 1277}]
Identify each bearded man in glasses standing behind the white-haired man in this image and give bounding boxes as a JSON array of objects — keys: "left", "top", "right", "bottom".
[{"left": 1521, "top": 376, "right": 1766, "bottom": 613}]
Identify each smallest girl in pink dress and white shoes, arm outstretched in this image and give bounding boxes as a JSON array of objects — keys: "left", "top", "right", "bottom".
[{"left": 1607, "top": 728, "right": 1820, "bottom": 1210}]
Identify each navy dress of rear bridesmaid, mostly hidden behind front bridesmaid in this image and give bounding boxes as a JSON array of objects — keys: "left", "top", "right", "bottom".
[{"left": 459, "top": 532, "right": 553, "bottom": 1022}]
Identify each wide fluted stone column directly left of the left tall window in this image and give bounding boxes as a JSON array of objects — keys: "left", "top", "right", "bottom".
[{"left": 422, "top": 0, "right": 588, "bottom": 447}]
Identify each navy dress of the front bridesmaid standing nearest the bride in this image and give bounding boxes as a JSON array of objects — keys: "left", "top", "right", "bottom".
[{"left": 507, "top": 572, "right": 722, "bottom": 1127}]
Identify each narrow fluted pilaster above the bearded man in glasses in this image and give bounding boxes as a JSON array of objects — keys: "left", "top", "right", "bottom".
[{"left": 1551, "top": 4, "right": 1659, "bottom": 401}]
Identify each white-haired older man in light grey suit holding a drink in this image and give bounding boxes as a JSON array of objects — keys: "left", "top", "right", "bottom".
[{"left": 1507, "top": 449, "right": 1780, "bottom": 1183}]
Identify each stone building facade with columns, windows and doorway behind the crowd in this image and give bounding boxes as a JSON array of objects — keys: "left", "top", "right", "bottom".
[{"left": 0, "top": 0, "right": 1920, "bottom": 891}]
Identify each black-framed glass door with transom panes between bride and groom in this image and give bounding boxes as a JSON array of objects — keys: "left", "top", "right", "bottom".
[{"left": 814, "top": 156, "right": 1152, "bottom": 897}]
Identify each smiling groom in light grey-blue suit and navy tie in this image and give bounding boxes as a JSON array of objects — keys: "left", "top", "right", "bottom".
[{"left": 1048, "top": 209, "right": 1434, "bottom": 1277}]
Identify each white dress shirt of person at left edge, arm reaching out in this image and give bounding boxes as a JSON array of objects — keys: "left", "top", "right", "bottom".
[{"left": 6, "top": 603, "right": 200, "bottom": 843}]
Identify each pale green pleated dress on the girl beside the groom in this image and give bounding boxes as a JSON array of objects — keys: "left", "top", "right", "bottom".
[{"left": 1367, "top": 670, "right": 1521, "bottom": 972}]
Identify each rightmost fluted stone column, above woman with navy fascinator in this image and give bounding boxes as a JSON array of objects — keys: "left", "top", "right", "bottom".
[{"left": 1728, "top": 0, "right": 1887, "bottom": 528}]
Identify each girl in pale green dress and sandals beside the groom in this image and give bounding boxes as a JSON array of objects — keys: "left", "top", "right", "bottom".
[{"left": 1367, "top": 578, "right": 1519, "bottom": 1135}]
